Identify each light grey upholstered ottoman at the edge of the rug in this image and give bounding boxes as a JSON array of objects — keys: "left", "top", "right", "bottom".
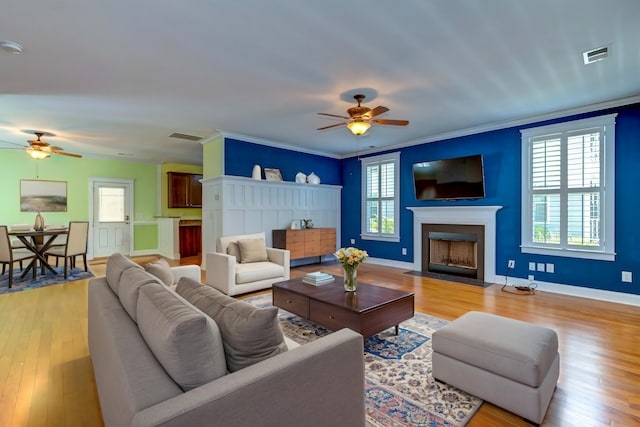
[{"left": 431, "top": 311, "right": 560, "bottom": 424}]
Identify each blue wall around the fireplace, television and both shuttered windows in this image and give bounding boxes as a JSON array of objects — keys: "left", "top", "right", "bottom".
[{"left": 342, "top": 104, "right": 640, "bottom": 294}]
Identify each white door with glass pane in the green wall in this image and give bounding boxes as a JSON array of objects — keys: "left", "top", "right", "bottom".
[{"left": 91, "top": 179, "right": 133, "bottom": 258}]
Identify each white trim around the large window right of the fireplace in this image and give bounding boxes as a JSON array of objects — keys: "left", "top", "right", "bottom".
[{"left": 520, "top": 114, "right": 618, "bottom": 261}]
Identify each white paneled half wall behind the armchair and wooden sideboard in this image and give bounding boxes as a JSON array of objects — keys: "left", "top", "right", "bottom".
[{"left": 202, "top": 176, "right": 342, "bottom": 269}]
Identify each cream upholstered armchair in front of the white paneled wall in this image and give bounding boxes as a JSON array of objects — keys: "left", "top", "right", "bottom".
[{"left": 205, "top": 233, "right": 290, "bottom": 295}]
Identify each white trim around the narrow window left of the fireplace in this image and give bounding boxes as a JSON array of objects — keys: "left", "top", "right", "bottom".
[{"left": 360, "top": 152, "right": 400, "bottom": 242}]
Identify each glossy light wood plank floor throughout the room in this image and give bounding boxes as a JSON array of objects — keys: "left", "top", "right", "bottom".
[{"left": 0, "top": 259, "right": 640, "bottom": 427}]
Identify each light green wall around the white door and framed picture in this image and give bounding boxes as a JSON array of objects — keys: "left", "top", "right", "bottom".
[{"left": 0, "top": 150, "right": 158, "bottom": 251}]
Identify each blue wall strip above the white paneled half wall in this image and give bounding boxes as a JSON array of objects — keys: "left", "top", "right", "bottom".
[{"left": 224, "top": 138, "right": 340, "bottom": 185}]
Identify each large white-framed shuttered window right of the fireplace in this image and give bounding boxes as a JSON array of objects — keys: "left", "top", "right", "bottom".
[{"left": 521, "top": 114, "right": 616, "bottom": 261}]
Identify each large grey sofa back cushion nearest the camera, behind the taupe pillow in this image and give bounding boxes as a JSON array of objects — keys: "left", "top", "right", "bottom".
[{"left": 137, "top": 284, "right": 227, "bottom": 391}]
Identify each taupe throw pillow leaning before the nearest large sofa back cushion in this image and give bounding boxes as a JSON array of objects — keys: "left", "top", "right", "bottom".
[{"left": 176, "top": 277, "right": 287, "bottom": 372}]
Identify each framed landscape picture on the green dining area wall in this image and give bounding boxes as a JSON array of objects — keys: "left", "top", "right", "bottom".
[{"left": 20, "top": 179, "right": 67, "bottom": 212}]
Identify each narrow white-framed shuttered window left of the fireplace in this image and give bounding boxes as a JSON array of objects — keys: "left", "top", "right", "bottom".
[{"left": 360, "top": 153, "right": 400, "bottom": 242}]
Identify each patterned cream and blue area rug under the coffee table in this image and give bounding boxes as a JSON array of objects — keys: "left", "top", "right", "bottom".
[{"left": 245, "top": 294, "right": 482, "bottom": 427}]
